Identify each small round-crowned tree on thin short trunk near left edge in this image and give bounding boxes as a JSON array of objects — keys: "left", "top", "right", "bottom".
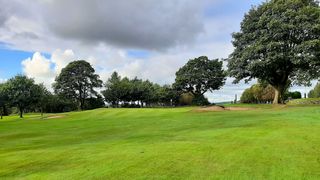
[{"left": 5, "top": 75, "right": 41, "bottom": 118}]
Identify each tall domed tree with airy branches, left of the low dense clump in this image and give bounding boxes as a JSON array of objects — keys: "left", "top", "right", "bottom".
[{"left": 53, "top": 60, "right": 102, "bottom": 110}]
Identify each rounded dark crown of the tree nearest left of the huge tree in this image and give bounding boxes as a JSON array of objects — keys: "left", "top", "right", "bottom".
[{"left": 174, "top": 56, "right": 226, "bottom": 100}]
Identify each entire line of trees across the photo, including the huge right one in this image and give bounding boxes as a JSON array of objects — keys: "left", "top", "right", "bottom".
[{"left": 0, "top": 0, "right": 320, "bottom": 116}]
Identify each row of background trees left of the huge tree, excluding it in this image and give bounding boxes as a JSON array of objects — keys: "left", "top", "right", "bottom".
[{"left": 0, "top": 56, "right": 226, "bottom": 117}]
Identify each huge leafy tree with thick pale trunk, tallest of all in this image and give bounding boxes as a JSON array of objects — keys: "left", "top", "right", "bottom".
[{"left": 228, "top": 0, "right": 320, "bottom": 104}]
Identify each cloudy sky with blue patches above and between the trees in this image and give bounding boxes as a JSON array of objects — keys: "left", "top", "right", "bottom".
[{"left": 0, "top": 0, "right": 311, "bottom": 102}]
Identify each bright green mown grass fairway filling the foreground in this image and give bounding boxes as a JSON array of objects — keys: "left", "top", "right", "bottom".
[{"left": 0, "top": 105, "right": 320, "bottom": 179}]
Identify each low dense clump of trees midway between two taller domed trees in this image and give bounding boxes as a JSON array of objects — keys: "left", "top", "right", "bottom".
[{"left": 101, "top": 72, "right": 178, "bottom": 107}]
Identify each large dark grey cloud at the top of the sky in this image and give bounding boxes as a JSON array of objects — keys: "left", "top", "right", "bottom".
[{"left": 42, "top": 0, "right": 203, "bottom": 50}]
